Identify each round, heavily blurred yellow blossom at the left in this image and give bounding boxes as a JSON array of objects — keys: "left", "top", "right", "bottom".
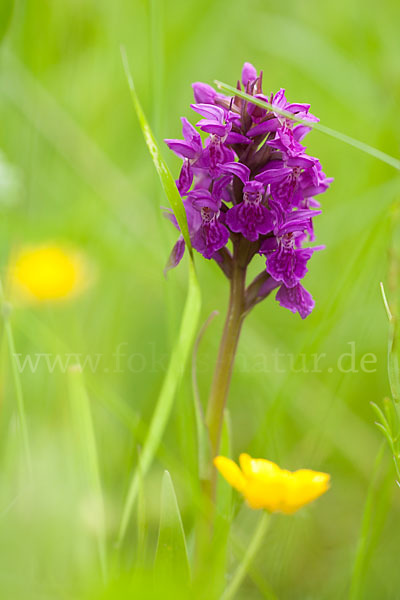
[{"left": 11, "top": 244, "right": 87, "bottom": 302}]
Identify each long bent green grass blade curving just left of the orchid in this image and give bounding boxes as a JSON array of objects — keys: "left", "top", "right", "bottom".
[{"left": 117, "top": 48, "right": 201, "bottom": 546}]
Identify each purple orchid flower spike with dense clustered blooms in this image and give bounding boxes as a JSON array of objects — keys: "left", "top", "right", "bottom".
[{"left": 162, "top": 63, "right": 332, "bottom": 318}]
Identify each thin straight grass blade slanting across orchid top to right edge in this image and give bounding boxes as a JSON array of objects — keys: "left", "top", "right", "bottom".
[{"left": 214, "top": 80, "right": 400, "bottom": 171}]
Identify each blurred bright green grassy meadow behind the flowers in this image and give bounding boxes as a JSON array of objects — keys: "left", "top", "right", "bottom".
[{"left": 0, "top": 0, "right": 400, "bottom": 600}]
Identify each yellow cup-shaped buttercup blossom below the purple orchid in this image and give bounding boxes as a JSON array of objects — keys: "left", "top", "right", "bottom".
[{"left": 214, "top": 454, "right": 330, "bottom": 515}]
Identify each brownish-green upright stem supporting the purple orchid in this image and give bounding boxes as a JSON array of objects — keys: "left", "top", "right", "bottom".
[{"left": 206, "top": 248, "right": 247, "bottom": 456}]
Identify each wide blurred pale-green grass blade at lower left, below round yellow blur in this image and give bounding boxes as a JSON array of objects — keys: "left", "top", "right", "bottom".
[{"left": 69, "top": 365, "right": 108, "bottom": 581}]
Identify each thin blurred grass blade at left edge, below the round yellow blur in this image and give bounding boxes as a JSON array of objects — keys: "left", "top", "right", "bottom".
[{"left": 0, "top": 280, "right": 32, "bottom": 477}]
